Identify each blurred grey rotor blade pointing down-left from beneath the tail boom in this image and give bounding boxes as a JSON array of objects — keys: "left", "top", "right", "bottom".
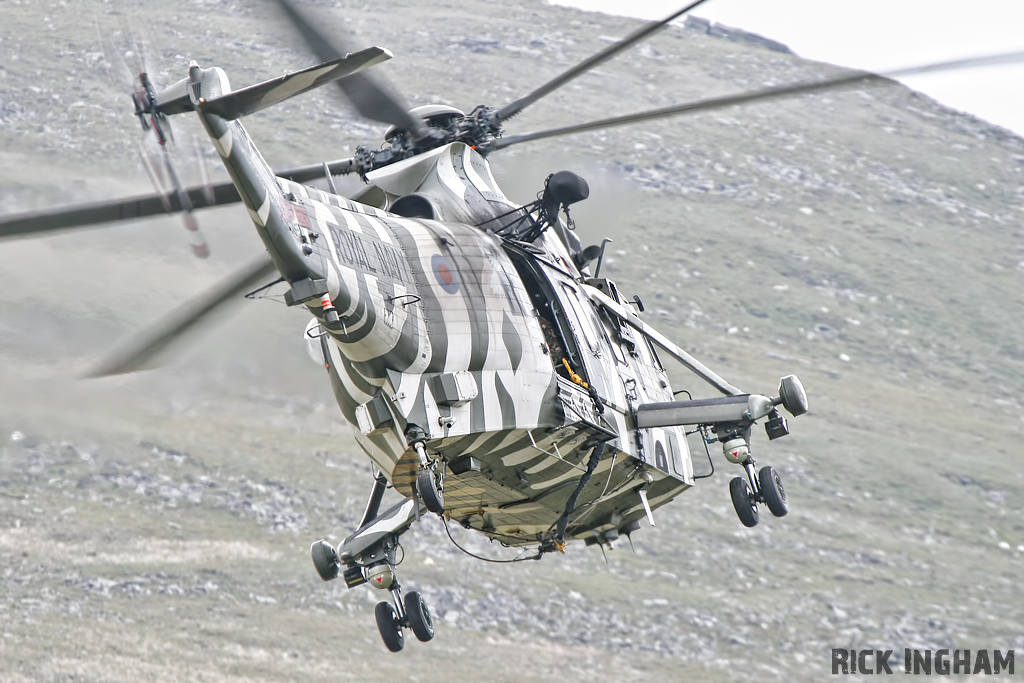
[{"left": 85, "top": 253, "right": 278, "bottom": 378}]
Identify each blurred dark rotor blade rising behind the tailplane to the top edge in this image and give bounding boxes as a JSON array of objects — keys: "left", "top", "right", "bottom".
[{"left": 278, "top": 0, "right": 424, "bottom": 137}]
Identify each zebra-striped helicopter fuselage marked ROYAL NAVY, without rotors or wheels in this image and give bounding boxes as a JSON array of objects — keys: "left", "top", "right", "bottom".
[{"left": 196, "top": 68, "right": 693, "bottom": 545}]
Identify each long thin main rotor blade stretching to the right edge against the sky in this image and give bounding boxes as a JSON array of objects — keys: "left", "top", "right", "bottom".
[{"left": 490, "top": 52, "right": 1024, "bottom": 152}]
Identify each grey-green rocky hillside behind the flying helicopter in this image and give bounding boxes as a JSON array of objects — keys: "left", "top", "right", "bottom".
[{"left": 0, "top": 0, "right": 1024, "bottom": 681}]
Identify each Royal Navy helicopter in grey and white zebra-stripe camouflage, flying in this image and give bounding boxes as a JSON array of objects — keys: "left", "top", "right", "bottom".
[{"left": 0, "top": 0, "right": 1021, "bottom": 651}]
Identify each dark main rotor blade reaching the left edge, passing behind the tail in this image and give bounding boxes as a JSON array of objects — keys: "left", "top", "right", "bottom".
[{"left": 0, "top": 159, "right": 354, "bottom": 239}]
